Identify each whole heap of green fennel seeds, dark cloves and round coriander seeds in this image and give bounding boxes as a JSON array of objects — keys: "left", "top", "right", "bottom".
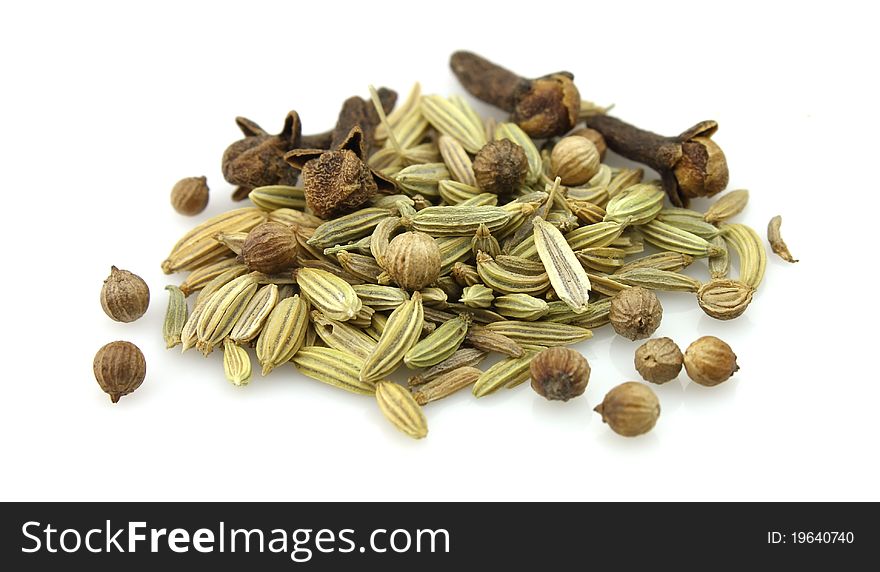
[{"left": 95, "top": 52, "right": 793, "bottom": 438}]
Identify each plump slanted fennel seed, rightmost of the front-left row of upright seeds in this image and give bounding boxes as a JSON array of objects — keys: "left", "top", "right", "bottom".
[{"left": 256, "top": 296, "right": 309, "bottom": 375}]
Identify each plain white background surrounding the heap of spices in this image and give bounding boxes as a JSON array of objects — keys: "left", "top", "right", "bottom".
[{"left": 0, "top": 2, "right": 880, "bottom": 500}]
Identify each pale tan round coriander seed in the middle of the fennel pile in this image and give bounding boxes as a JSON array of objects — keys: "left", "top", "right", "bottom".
[{"left": 385, "top": 231, "right": 442, "bottom": 291}]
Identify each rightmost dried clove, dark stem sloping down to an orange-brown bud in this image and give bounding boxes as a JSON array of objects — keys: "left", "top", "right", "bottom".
[{"left": 589, "top": 115, "right": 730, "bottom": 207}]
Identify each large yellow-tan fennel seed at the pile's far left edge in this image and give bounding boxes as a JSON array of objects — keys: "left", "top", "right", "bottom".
[{"left": 162, "top": 207, "right": 268, "bottom": 274}]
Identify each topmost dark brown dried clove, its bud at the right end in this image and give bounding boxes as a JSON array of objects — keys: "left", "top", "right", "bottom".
[{"left": 449, "top": 51, "right": 581, "bottom": 139}]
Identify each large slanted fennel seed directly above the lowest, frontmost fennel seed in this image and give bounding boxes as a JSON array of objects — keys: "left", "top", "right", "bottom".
[{"left": 360, "top": 292, "right": 424, "bottom": 381}]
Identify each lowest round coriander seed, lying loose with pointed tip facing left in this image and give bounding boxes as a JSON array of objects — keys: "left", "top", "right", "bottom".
[{"left": 593, "top": 381, "right": 660, "bottom": 437}]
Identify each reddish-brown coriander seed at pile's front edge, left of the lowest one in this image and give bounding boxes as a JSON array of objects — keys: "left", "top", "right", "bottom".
[{"left": 529, "top": 347, "right": 590, "bottom": 401}]
